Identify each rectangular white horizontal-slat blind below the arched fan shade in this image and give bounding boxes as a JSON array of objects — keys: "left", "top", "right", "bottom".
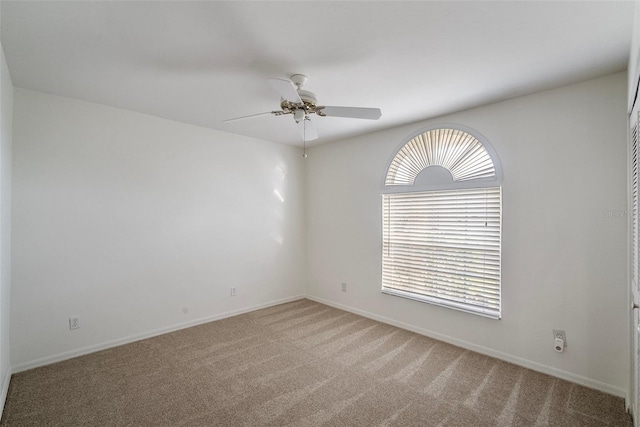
[{"left": 382, "top": 187, "right": 502, "bottom": 318}]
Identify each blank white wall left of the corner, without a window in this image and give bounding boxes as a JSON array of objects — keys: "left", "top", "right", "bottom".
[{"left": 11, "top": 88, "right": 305, "bottom": 370}]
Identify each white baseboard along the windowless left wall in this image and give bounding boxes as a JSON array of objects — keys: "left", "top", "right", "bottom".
[{"left": 11, "top": 295, "right": 306, "bottom": 374}]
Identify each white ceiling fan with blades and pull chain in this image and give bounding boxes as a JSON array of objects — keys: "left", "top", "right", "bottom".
[{"left": 223, "top": 74, "right": 382, "bottom": 141}]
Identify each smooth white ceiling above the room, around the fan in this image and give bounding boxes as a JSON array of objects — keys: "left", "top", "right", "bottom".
[{"left": 0, "top": 0, "right": 634, "bottom": 145}]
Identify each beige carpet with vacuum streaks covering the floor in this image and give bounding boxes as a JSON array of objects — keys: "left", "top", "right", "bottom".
[{"left": 0, "top": 300, "right": 631, "bottom": 427}]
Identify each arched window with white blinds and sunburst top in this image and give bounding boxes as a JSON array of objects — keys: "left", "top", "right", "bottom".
[{"left": 382, "top": 126, "right": 502, "bottom": 319}]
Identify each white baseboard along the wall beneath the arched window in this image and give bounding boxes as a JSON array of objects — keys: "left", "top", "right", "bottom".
[{"left": 306, "top": 295, "right": 627, "bottom": 398}]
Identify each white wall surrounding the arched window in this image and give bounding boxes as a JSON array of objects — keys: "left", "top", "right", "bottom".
[{"left": 307, "top": 73, "right": 629, "bottom": 396}]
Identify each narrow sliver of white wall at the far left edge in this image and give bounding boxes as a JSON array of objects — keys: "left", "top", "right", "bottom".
[{"left": 0, "top": 45, "right": 13, "bottom": 408}]
